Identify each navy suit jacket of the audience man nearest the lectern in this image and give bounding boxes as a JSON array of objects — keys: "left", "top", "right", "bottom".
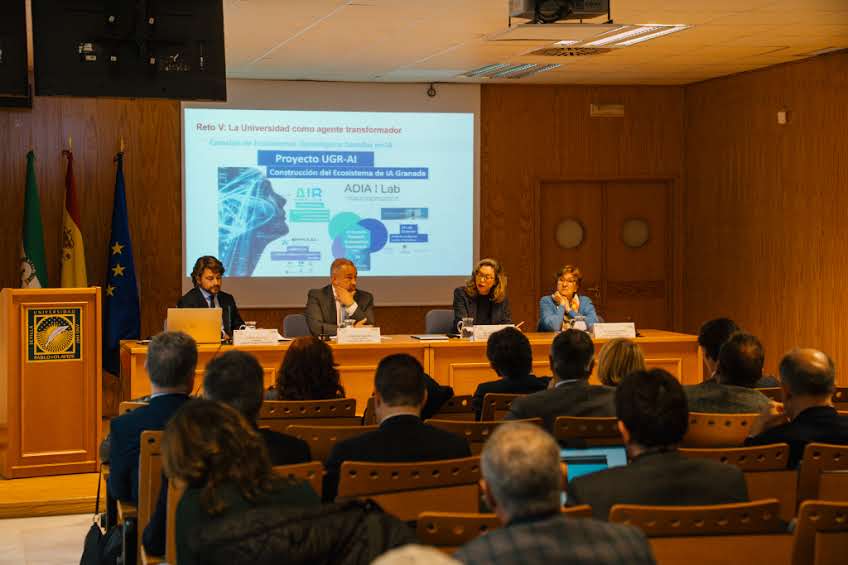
[{"left": 107, "top": 394, "right": 189, "bottom": 504}]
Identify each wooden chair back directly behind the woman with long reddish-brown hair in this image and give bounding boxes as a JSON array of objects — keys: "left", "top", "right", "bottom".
[{"left": 258, "top": 398, "right": 362, "bottom": 433}]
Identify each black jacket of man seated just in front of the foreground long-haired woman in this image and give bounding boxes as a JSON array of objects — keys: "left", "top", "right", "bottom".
[{"left": 142, "top": 429, "right": 311, "bottom": 555}]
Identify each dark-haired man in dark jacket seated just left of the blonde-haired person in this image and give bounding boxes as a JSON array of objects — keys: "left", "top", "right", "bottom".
[{"left": 506, "top": 330, "right": 615, "bottom": 430}]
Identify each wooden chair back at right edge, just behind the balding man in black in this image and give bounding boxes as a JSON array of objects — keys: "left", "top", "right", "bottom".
[{"left": 798, "top": 443, "right": 848, "bottom": 502}]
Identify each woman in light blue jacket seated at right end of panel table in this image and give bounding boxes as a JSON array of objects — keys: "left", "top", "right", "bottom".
[{"left": 539, "top": 265, "right": 598, "bottom": 332}]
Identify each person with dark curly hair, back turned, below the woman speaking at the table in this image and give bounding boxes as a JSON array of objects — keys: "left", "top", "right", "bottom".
[{"left": 471, "top": 328, "right": 550, "bottom": 420}]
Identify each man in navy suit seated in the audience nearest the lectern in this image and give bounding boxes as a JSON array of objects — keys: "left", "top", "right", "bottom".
[{"left": 107, "top": 332, "right": 197, "bottom": 555}]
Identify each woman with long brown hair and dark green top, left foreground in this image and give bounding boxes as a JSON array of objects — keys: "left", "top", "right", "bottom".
[{"left": 162, "top": 400, "right": 321, "bottom": 565}]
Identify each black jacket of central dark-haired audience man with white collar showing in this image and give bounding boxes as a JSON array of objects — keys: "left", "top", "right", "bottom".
[{"left": 324, "top": 415, "right": 471, "bottom": 502}]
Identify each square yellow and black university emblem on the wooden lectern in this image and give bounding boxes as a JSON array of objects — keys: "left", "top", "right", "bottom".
[{"left": 27, "top": 308, "right": 82, "bottom": 361}]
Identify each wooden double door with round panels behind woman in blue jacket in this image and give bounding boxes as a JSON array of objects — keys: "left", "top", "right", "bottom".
[{"left": 538, "top": 181, "right": 673, "bottom": 329}]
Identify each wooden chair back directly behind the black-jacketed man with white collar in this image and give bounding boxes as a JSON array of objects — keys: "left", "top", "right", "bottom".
[{"left": 338, "top": 457, "right": 480, "bottom": 521}]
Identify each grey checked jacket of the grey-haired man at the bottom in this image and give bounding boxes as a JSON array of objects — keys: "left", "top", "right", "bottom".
[{"left": 453, "top": 514, "right": 654, "bottom": 565}]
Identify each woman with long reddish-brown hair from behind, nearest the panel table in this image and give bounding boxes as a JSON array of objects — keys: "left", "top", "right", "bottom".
[{"left": 265, "top": 336, "right": 345, "bottom": 400}]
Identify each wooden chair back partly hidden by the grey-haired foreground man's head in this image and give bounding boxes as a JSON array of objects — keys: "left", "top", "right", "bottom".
[{"left": 416, "top": 504, "right": 592, "bottom": 553}]
